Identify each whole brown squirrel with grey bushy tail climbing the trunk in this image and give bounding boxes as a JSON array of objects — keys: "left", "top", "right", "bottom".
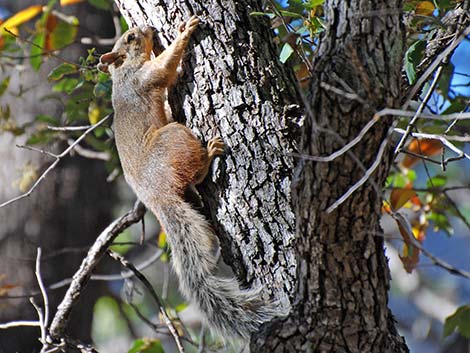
[{"left": 98, "top": 16, "right": 280, "bottom": 339}]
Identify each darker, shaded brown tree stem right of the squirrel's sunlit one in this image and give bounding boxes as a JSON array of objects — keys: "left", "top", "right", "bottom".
[{"left": 257, "top": 0, "right": 408, "bottom": 353}]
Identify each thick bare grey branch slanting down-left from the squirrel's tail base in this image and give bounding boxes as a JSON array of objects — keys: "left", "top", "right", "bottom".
[{"left": 50, "top": 201, "right": 145, "bottom": 339}]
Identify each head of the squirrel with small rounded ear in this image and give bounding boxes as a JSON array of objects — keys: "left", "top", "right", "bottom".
[{"left": 98, "top": 26, "right": 156, "bottom": 74}]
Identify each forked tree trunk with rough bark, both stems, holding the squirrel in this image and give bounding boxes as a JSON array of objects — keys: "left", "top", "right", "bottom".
[{"left": 117, "top": 0, "right": 407, "bottom": 353}]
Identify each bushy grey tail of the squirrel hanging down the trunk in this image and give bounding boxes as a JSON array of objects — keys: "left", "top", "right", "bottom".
[{"left": 152, "top": 200, "right": 280, "bottom": 338}]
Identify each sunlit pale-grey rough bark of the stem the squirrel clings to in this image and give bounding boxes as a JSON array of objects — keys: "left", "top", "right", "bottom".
[{"left": 116, "top": 0, "right": 300, "bottom": 305}]
